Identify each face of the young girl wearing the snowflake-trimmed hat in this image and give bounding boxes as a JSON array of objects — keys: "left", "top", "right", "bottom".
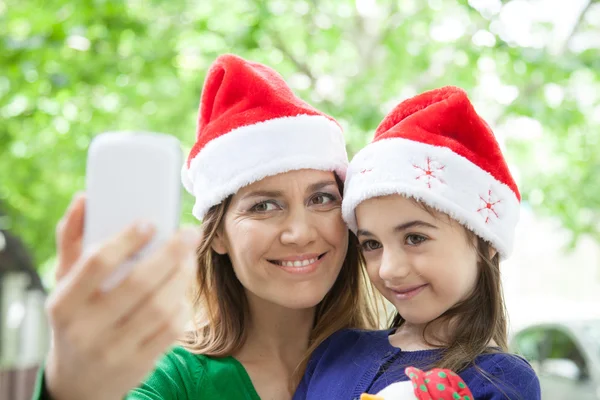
[{"left": 356, "top": 195, "right": 478, "bottom": 325}]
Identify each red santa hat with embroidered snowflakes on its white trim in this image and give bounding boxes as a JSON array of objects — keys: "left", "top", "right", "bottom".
[{"left": 342, "top": 86, "right": 521, "bottom": 258}]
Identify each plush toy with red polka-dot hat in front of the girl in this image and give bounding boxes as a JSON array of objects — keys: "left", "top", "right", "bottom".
[{"left": 360, "top": 367, "right": 474, "bottom": 400}]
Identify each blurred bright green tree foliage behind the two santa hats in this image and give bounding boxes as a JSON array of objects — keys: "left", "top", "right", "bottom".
[{"left": 0, "top": 0, "right": 600, "bottom": 282}]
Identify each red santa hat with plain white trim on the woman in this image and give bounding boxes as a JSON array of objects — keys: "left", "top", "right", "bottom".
[{"left": 181, "top": 54, "right": 348, "bottom": 220}]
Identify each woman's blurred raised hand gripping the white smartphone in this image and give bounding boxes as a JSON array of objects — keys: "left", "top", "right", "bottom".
[{"left": 45, "top": 192, "right": 199, "bottom": 400}]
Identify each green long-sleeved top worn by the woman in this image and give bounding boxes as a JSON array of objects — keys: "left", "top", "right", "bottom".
[{"left": 33, "top": 347, "right": 260, "bottom": 400}]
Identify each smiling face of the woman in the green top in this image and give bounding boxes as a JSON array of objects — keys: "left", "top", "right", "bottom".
[{"left": 213, "top": 169, "right": 348, "bottom": 309}]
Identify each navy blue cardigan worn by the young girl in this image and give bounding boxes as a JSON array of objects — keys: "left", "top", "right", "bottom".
[{"left": 294, "top": 330, "right": 541, "bottom": 400}]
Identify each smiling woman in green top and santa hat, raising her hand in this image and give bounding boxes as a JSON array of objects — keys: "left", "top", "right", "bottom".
[{"left": 35, "top": 55, "right": 375, "bottom": 400}]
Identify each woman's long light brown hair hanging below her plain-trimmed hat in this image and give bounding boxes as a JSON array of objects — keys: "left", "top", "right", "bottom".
[{"left": 183, "top": 176, "right": 378, "bottom": 387}]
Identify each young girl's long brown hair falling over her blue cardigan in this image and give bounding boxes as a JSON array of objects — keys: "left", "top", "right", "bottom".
[{"left": 390, "top": 216, "right": 508, "bottom": 372}]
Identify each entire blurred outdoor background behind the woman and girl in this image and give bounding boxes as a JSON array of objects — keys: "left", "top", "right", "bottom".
[{"left": 0, "top": 0, "right": 600, "bottom": 399}]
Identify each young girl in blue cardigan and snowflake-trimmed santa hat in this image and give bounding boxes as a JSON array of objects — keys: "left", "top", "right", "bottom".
[{"left": 295, "top": 87, "right": 540, "bottom": 400}]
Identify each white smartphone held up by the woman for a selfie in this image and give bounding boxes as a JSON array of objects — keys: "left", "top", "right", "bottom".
[{"left": 83, "top": 132, "right": 183, "bottom": 291}]
